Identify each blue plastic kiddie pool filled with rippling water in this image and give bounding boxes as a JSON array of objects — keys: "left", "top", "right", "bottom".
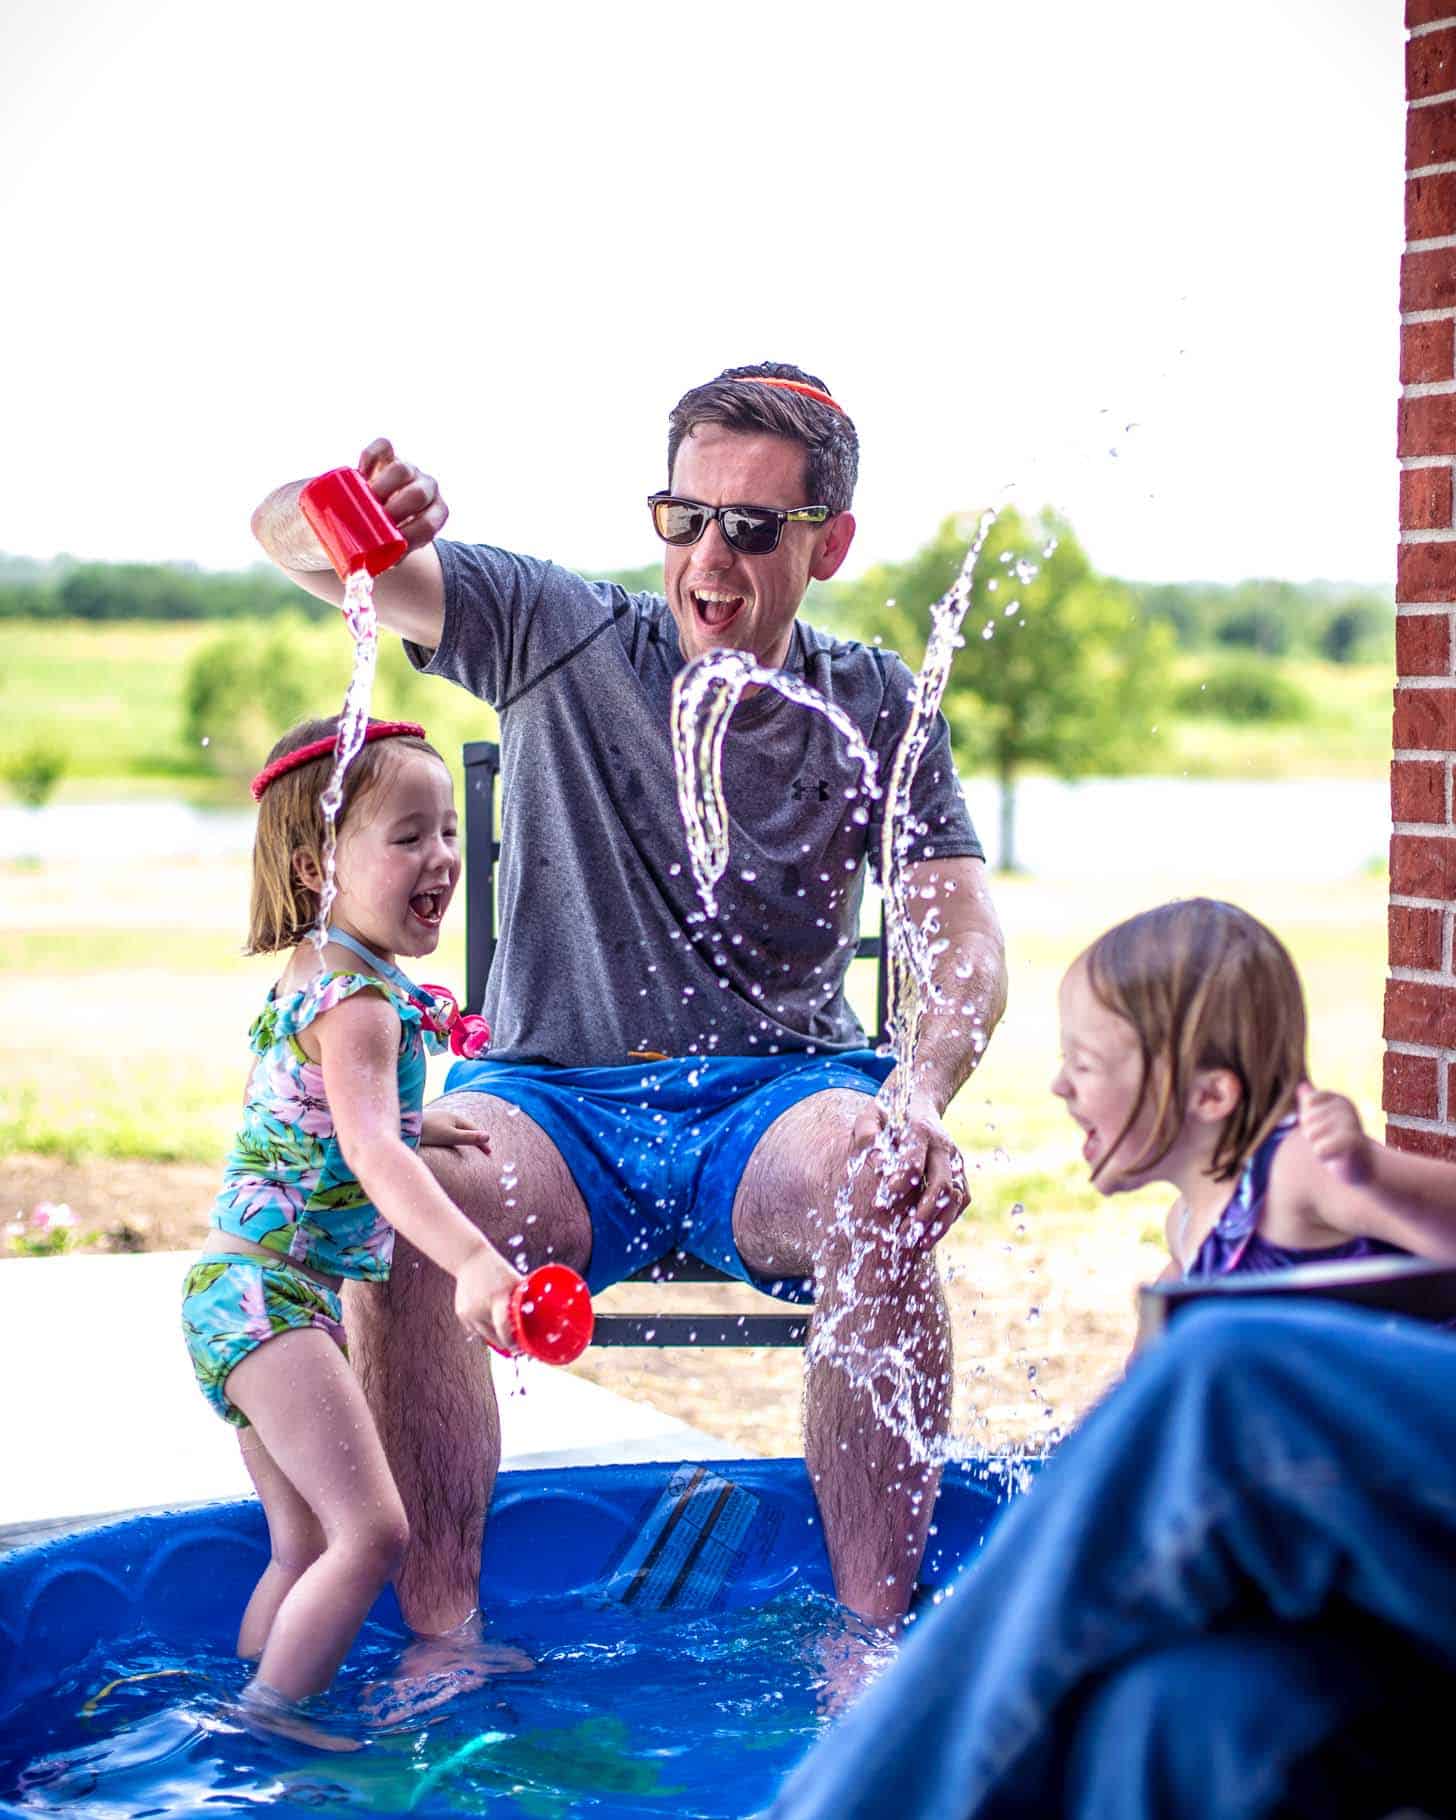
[{"left": 0, "top": 1460, "right": 1006, "bottom": 1820}]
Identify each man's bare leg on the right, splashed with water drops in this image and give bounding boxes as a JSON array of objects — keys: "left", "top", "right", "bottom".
[{"left": 733, "top": 1092, "right": 952, "bottom": 1623}]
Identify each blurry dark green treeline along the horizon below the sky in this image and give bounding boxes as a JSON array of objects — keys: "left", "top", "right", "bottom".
[{"left": 0, "top": 553, "right": 1394, "bottom": 662}]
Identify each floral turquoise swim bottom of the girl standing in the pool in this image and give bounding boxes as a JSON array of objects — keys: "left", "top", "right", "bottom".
[{"left": 182, "top": 1256, "right": 349, "bottom": 1429}]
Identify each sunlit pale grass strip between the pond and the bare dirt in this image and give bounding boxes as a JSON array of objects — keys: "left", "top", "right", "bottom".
[{"left": 0, "top": 861, "right": 1385, "bottom": 1266}]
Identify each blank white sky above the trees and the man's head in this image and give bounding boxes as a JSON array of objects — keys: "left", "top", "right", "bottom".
[{"left": 0, "top": 0, "right": 1403, "bottom": 582}]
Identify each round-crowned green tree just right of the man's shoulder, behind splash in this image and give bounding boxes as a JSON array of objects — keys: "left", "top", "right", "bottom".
[{"left": 839, "top": 510, "right": 1174, "bottom": 872}]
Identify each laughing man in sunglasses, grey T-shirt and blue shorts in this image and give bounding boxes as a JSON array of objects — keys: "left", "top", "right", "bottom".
[{"left": 253, "top": 364, "right": 1005, "bottom": 1659}]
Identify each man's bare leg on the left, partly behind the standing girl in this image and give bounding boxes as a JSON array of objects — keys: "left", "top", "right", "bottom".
[{"left": 348, "top": 1094, "right": 592, "bottom": 1636}]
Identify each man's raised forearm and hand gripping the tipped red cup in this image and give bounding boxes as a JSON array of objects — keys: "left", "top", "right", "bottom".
[{"left": 253, "top": 437, "right": 450, "bottom": 650}]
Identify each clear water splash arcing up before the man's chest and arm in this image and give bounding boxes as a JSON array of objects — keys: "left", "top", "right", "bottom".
[{"left": 672, "top": 511, "right": 996, "bottom": 1465}]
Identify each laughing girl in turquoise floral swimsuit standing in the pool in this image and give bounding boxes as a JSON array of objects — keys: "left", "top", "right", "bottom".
[{"left": 182, "top": 721, "right": 519, "bottom": 1742}]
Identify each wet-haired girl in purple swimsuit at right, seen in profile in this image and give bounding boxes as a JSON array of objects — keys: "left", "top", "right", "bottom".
[{"left": 1052, "top": 897, "right": 1456, "bottom": 1279}]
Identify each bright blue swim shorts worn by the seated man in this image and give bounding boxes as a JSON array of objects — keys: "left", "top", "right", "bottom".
[{"left": 434, "top": 1048, "right": 894, "bottom": 1301}]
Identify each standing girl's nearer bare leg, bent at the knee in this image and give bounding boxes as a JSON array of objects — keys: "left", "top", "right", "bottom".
[{"left": 228, "top": 1329, "right": 410, "bottom": 1700}]
